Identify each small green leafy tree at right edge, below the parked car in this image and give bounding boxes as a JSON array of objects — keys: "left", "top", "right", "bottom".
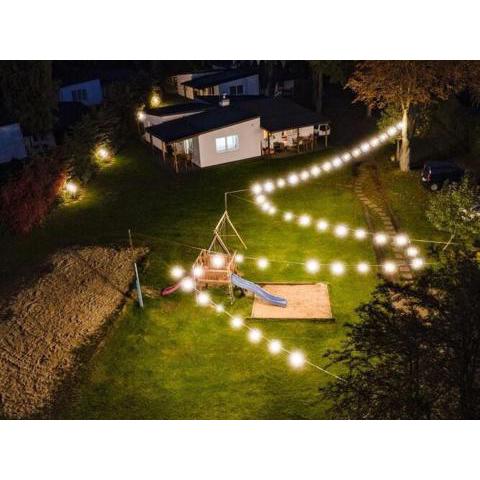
[{"left": 426, "top": 175, "right": 480, "bottom": 246}]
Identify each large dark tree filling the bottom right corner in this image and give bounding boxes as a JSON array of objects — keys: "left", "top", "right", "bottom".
[{"left": 321, "top": 249, "right": 480, "bottom": 419}]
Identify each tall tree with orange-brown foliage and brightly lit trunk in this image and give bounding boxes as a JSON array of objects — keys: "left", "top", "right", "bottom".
[{"left": 347, "top": 60, "right": 479, "bottom": 171}]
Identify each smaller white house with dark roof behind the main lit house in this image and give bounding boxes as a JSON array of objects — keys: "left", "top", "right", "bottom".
[{"left": 177, "top": 68, "right": 260, "bottom": 99}]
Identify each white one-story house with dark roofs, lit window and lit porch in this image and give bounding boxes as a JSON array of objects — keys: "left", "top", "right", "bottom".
[{"left": 144, "top": 96, "right": 329, "bottom": 168}]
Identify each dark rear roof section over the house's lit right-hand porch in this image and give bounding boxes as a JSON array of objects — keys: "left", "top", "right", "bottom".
[{"left": 197, "top": 95, "right": 329, "bottom": 132}]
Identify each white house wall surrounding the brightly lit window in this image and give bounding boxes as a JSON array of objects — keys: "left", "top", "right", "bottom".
[{"left": 193, "top": 118, "right": 263, "bottom": 168}]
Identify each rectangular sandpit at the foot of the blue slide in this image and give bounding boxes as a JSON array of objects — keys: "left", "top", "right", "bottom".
[{"left": 251, "top": 283, "right": 333, "bottom": 321}]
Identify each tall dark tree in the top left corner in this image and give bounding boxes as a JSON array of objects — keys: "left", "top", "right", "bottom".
[{"left": 0, "top": 60, "right": 57, "bottom": 133}]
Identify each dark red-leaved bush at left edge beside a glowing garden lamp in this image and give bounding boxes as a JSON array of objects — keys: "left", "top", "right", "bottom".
[{"left": 0, "top": 157, "right": 66, "bottom": 234}]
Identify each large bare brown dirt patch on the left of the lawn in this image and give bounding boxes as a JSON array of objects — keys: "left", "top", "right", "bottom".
[{"left": 0, "top": 247, "right": 146, "bottom": 418}]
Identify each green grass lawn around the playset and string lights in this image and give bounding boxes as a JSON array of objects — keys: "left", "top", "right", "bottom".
[{"left": 0, "top": 141, "right": 442, "bottom": 419}]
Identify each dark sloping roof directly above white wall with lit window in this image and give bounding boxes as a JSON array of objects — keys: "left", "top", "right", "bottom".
[{"left": 146, "top": 107, "right": 258, "bottom": 142}]
